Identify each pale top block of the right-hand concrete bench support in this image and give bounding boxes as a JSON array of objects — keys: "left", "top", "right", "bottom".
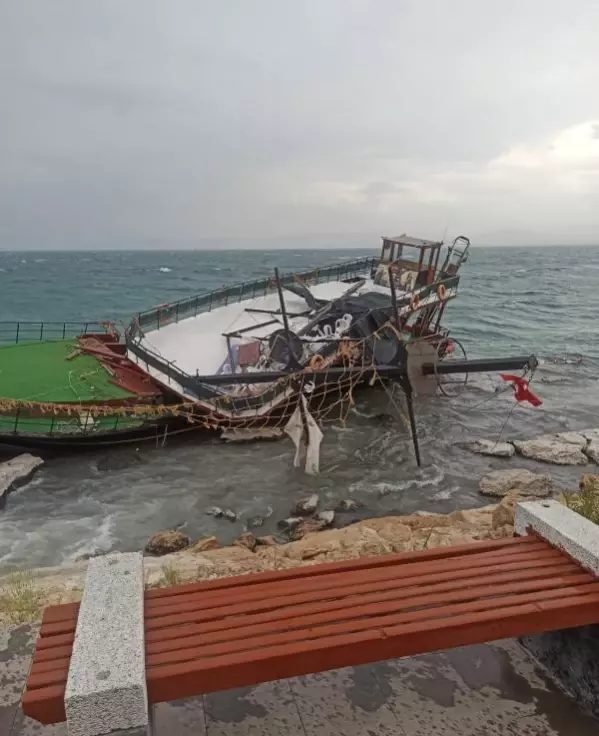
[{"left": 515, "top": 501, "right": 599, "bottom": 576}]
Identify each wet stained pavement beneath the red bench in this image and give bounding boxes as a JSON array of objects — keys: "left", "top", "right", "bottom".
[{"left": 0, "top": 625, "right": 599, "bottom": 736}]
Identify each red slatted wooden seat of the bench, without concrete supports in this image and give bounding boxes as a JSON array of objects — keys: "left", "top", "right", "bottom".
[{"left": 22, "top": 536, "right": 599, "bottom": 724}]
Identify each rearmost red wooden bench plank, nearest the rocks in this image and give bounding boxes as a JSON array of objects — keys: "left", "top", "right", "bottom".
[{"left": 146, "top": 536, "right": 538, "bottom": 601}]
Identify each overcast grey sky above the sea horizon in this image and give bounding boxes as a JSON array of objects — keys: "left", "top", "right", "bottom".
[{"left": 0, "top": 0, "right": 599, "bottom": 249}]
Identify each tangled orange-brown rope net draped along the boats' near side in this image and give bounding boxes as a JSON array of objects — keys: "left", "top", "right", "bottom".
[{"left": 0, "top": 322, "right": 440, "bottom": 434}]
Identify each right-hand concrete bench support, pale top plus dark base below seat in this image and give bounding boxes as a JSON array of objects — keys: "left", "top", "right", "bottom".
[{"left": 516, "top": 501, "right": 599, "bottom": 718}]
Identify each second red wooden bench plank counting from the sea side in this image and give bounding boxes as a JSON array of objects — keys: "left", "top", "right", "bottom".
[{"left": 145, "top": 544, "right": 563, "bottom": 619}]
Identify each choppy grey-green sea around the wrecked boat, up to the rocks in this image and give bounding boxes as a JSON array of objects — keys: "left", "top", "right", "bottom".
[{"left": 0, "top": 246, "right": 599, "bottom": 569}]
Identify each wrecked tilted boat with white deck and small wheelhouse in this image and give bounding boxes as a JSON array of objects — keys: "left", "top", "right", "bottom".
[{"left": 125, "top": 235, "right": 470, "bottom": 429}]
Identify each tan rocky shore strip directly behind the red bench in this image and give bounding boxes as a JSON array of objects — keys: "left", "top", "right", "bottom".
[{"left": 0, "top": 495, "right": 516, "bottom": 623}]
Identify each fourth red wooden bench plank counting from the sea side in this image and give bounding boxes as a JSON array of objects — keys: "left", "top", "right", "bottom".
[{"left": 146, "top": 564, "right": 594, "bottom": 646}]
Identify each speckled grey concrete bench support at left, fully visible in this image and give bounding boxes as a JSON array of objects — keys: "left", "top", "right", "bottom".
[{"left": 65, "top": 552, "right": 150, "bottom": 736}]
